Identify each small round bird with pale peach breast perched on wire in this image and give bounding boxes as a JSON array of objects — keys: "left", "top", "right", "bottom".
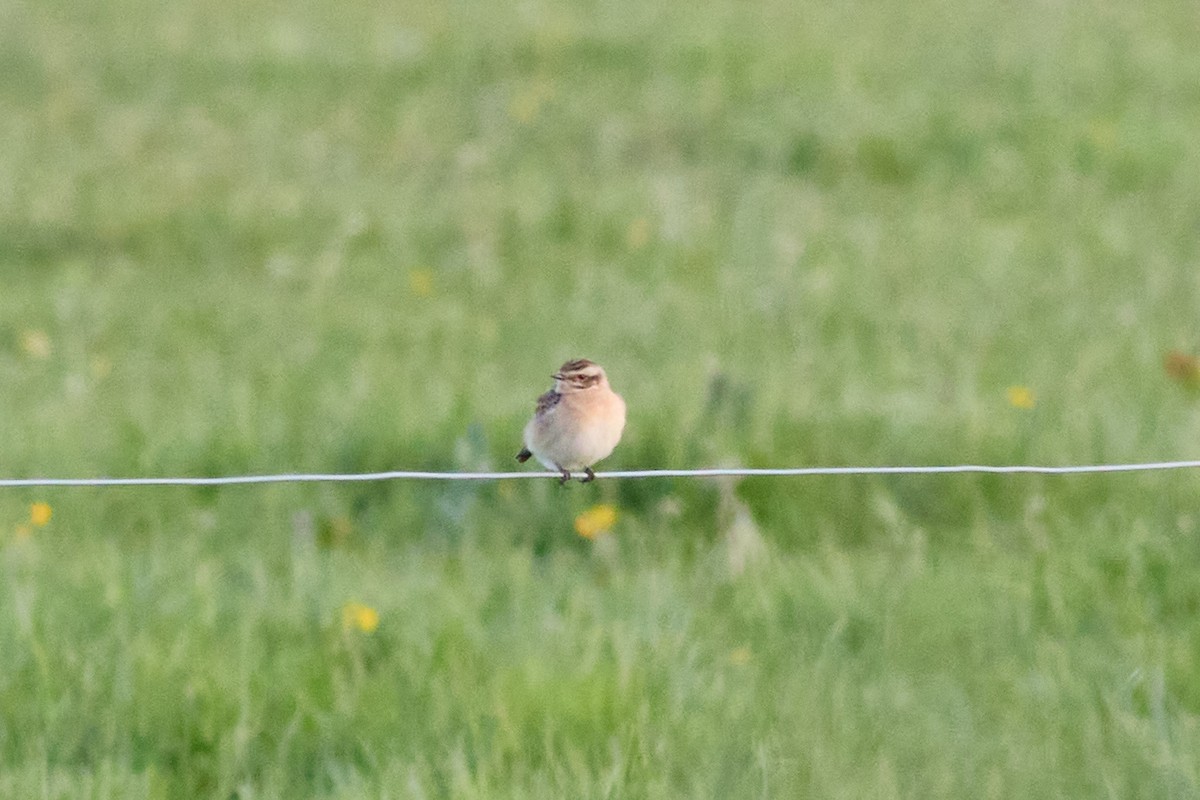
[{"left": 517, "top": 359, "right": 625, "bottom": 485}]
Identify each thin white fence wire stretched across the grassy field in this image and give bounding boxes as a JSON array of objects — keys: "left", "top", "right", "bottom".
[{"left": 0, "top": 461, "right": 1200, "bottom": 488}]
